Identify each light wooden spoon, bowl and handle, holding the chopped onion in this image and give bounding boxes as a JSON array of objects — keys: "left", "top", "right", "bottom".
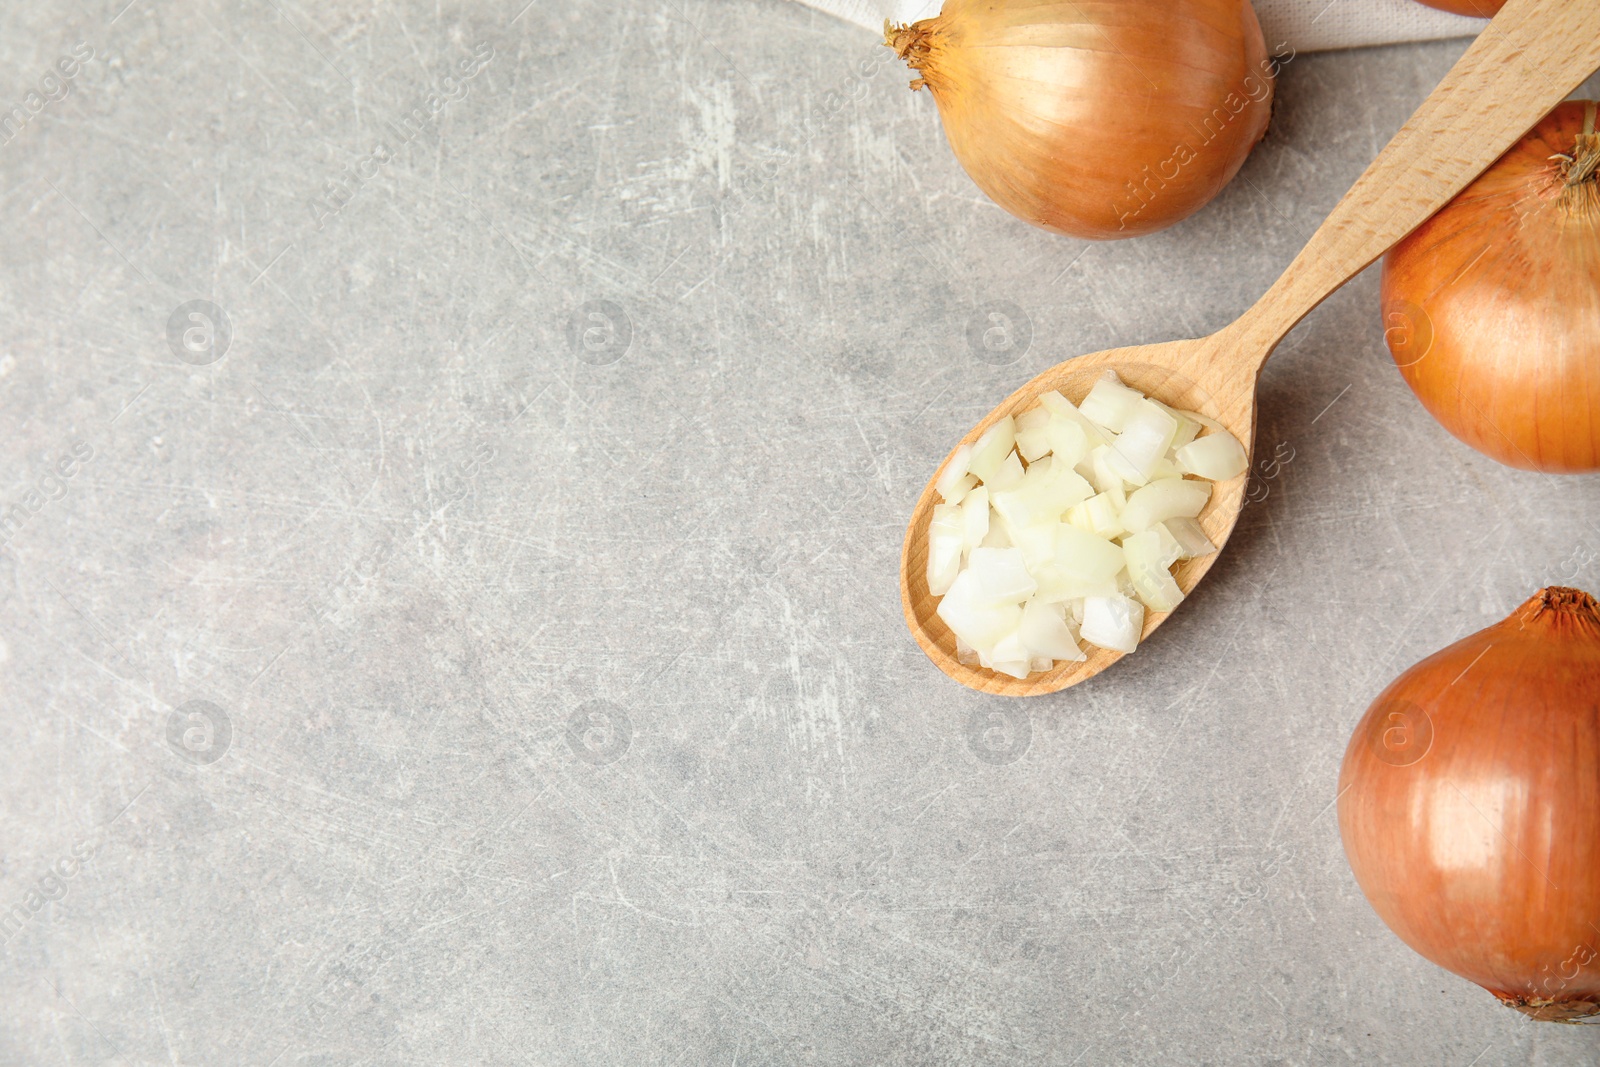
[{"left": 901, "top": 0, "right": 1600, "bottom": 696}]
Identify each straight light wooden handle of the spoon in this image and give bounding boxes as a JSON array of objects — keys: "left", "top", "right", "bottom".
[{"left": 1238, "top": 0, "right": 1600, "bottom": 355}]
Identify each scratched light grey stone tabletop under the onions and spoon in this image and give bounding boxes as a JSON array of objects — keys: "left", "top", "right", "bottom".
[{"left": 0, "top": 0, "right": 1600, "bottom": 1067}]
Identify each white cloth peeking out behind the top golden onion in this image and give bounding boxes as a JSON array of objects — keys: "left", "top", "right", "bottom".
[{"left": 787, "top": 0, "right": 1485, "bottom": 51}]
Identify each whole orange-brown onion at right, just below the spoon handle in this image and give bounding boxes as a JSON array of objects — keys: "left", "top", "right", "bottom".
[{"left": 1382, "top": 101, "right": 1600, "bottom": 474}]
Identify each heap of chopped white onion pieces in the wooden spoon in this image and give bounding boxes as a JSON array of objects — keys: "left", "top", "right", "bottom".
[{"left": 928, "top": 371, "right": 1248, "bottom": 678}]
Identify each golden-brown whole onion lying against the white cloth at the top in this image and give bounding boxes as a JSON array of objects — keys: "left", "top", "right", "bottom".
[{"left": 886, "top": 0, "right": 1278, "bottom": 240}]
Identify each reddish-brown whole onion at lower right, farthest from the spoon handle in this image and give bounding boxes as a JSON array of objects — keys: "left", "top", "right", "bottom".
[{"left": 1338, "top": 589, "right": 1600, "bottom": 1021}]
